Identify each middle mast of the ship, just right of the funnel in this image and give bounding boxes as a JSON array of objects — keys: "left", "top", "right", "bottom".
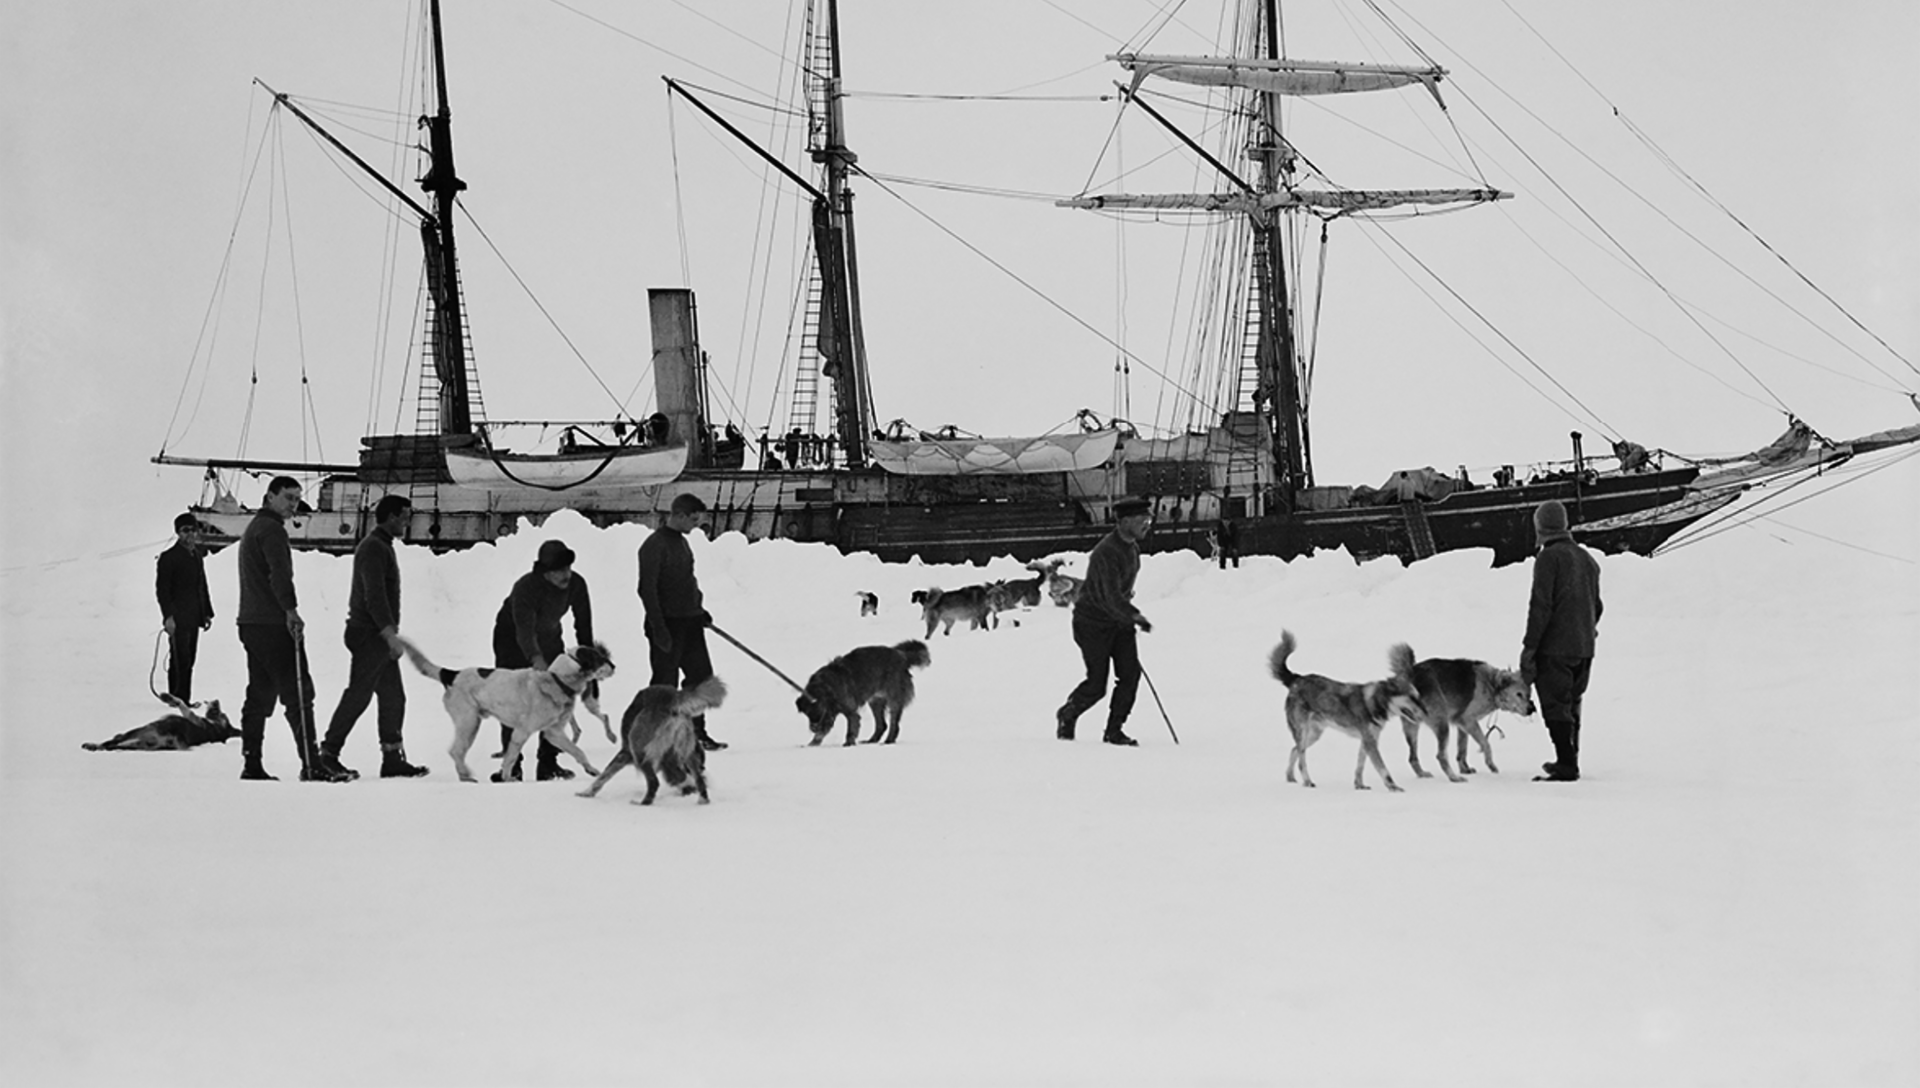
[{"left": 808, "top": 0, "right": 874, "bottom": 468}]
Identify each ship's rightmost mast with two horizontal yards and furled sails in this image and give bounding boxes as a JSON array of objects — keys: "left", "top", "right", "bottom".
[{"left": 1060, "top": 0, "right": 1511, "bottom": 509}]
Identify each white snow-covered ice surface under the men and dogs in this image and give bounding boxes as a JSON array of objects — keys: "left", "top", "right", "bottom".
[{"left": 0, "top": 495, "right": 1920, "bottom": 1088}]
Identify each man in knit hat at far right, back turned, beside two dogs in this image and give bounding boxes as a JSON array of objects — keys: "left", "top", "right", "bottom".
[{"left": 1521, "top": 499, "right": 1601, "bottom": 783}]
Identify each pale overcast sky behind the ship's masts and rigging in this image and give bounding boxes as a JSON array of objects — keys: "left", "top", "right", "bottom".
[{"left": 0, "top": 0, "right": 1920, "bottom": 566}]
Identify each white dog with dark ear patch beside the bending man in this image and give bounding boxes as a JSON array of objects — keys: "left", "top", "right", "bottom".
[{"left": 399, "top": 639, "right": 612, "bottom": 783}]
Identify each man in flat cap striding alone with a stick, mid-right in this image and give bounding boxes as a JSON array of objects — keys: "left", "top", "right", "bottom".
[{"left": 1054, "top": 499, "right": 1154, "bottom": 748}]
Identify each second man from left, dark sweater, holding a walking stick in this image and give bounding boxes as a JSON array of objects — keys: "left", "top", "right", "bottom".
[{"left": 234, "top": 476, "right": 348, "bottom": 783}]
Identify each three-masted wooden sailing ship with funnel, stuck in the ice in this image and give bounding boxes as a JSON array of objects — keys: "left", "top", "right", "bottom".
[{"left": 156, "top": 0, "right": 1920, "bottom": 564}]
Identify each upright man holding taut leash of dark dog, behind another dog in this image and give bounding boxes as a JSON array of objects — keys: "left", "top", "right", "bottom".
[{"left": 639, "top": 495, "right": 726, "bottom": 752}]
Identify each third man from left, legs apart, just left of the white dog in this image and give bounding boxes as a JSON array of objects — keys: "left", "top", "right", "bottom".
[{"left": 321, "top": 495, "right": 426, "bottom": 779}]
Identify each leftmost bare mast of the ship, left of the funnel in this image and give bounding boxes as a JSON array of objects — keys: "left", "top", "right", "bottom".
[{"left": 420, "top": 0, "right": 472, "bottom": 434}]
